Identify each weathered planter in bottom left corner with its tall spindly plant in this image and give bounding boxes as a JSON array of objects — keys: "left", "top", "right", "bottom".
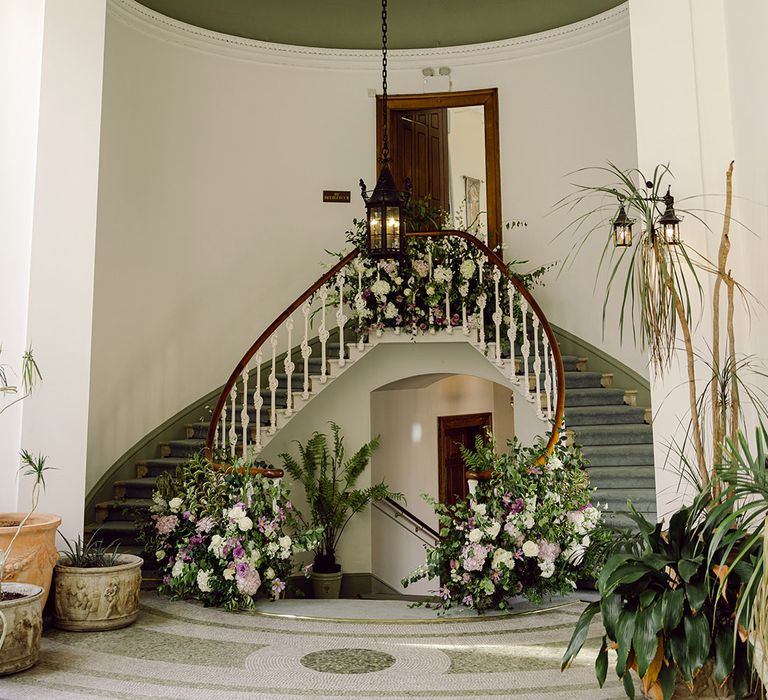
[{"left": 0, "top": 451, "right": 54, "bottom": 676}]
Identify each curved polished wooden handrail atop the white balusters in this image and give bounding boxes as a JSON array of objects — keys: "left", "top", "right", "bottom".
[{"left": 205, "top": 229, "right": 565, "bottom": 462}]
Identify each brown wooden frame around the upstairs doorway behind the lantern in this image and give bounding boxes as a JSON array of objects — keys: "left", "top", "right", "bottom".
[{"left": 376, "top": 88, "right": 502, "bottom": 249}]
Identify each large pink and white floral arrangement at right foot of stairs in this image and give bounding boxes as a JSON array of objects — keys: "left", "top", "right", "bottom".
[{"left": 403, "top": 435, "right": 610, "bottom": 610}]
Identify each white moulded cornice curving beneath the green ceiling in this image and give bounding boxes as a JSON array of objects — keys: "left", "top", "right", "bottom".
[{"left": 107, "top": 0, "right": 629, "bottom": 70}]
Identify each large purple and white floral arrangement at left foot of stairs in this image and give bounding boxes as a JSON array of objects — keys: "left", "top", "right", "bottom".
[{"left": 143, "top": 458, "right": 321, "bottom": 610}]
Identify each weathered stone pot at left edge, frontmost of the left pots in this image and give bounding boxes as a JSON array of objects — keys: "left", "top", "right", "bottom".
[{"left": 0, "top": 584, "right": 43, "bottom": 676}]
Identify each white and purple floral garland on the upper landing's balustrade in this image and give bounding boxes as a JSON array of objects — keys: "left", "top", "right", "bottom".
[{"left": 328, "top": 206, "right": 552, "bottom": 337}]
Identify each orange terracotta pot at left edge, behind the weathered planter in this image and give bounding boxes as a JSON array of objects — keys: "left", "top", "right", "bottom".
[{"left": 0, "top": 513, "right": 61, "bottom": 608}]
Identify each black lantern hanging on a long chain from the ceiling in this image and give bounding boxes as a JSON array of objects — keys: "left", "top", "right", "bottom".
[{"left": 360, "top": 0, "right": 411, "bottom": 258}]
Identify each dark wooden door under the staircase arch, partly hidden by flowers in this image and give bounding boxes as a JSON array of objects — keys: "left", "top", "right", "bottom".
[{"left": 437, "top": 413, "right": 492, "bottom": 505}]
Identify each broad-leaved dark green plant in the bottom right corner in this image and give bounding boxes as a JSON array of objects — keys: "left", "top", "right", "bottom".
[{"left": 562, "top": 492, "right": 758, "bottom": 700}]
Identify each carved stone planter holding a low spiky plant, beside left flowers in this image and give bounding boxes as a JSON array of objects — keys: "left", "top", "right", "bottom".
[{"left": 53, "top": 554, "right": 144, "bottom": 632}]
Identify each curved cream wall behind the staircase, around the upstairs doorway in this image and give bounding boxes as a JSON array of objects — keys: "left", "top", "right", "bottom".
[{"left": 88, "top": 0, "right": 643, "bottom": 486}]
